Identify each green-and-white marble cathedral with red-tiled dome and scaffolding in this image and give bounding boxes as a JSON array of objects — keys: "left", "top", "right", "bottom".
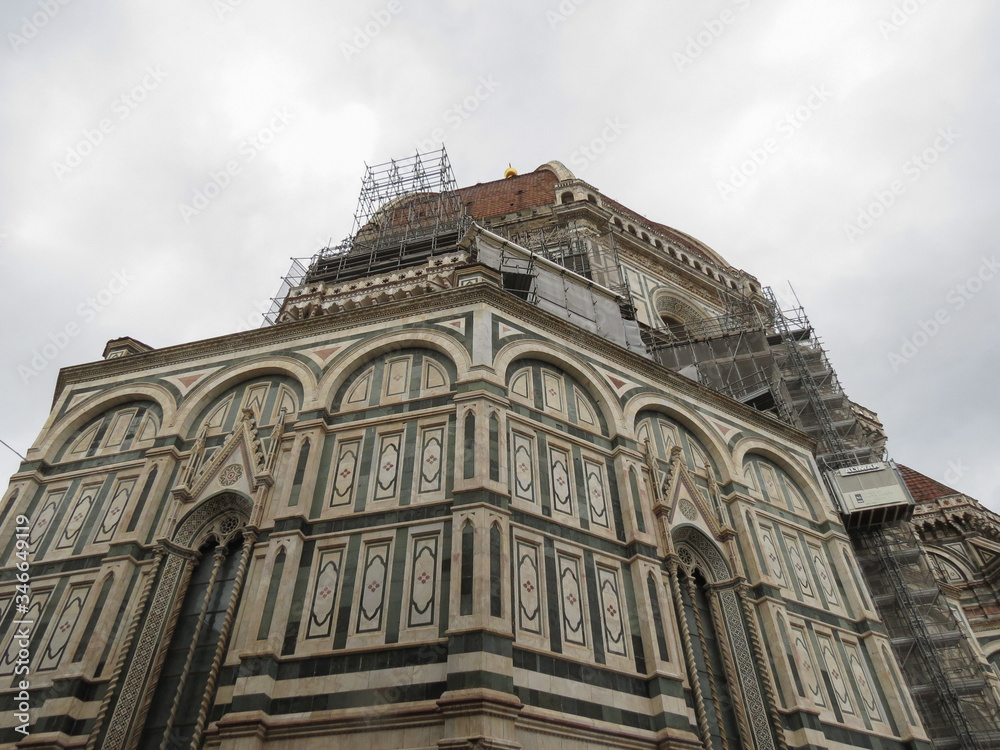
[{"left": 0, "top": 149, "right": 1000, "bottom": 750}]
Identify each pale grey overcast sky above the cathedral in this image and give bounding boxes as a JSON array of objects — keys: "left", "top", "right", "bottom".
[{"left": 0, "top": 0, "right": 1000, "bottom": 510}]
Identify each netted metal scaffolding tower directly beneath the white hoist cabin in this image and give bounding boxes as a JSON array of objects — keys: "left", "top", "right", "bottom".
[{"left": 851, "top": 521, "right": 1000, "bottom": 750}]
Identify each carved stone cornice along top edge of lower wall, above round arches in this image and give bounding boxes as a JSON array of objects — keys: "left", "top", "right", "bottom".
[{"left": 53, "top": 283, "right": 815, "bottom": 452}]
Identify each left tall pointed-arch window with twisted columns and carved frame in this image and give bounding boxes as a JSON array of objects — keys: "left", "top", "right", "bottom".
[{"left": 94, "top": 492, "right": 256, "bottom": 750}]
